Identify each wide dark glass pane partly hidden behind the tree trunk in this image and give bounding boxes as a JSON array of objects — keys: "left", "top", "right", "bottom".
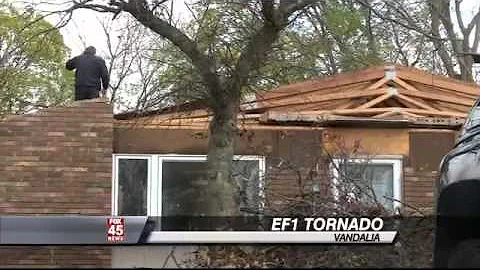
[{"left": 157, "top": 160, "right": 260, "bottom": 231}]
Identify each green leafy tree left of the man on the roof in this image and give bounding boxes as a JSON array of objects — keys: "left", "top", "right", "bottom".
[{"left": 0, "top": 2, "right": 73, "bottom": 115}]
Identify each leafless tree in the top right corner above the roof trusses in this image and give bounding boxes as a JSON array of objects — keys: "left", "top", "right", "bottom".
[{"left": 357, "top": 0, "right": 480, "bottom": 81}]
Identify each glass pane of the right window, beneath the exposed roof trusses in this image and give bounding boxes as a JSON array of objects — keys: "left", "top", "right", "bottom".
[{"left": 344, "top": 163, "right": 394, "bottom": 210}]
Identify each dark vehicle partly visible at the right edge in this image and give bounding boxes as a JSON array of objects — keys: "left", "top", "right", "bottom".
[{"left": 434, "top": 99, "right": 480, "bottom": 268}]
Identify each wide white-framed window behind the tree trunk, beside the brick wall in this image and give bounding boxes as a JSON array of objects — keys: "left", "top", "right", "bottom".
[{"left": 112, "top": 154, "right": 265, "bottom": 216}]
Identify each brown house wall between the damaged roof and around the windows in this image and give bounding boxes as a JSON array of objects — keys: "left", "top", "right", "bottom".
[{"left": 114, "top": 127, "right": 456, "bottom": 210}]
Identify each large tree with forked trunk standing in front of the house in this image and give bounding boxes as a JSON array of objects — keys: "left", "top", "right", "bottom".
[{"left": 44, "top": 0, "right": 318, "bottom": 216}]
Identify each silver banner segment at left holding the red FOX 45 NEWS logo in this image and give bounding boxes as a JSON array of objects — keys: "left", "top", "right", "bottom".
[{"left": 0, "top": 216, "right": 148, "bottom": 245}]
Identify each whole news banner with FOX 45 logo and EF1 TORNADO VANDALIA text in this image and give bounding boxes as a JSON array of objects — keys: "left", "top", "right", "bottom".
[{"left": 0, "top": 216, "right": 397, "bottom": 245}]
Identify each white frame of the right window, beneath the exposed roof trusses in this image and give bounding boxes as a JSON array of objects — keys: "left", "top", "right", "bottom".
[{"left": 330, "top": 156, "right": 403, "bottom": 212}]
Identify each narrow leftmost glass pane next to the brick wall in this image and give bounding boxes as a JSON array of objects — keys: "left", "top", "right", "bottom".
[{"left": 118, "top": 158, "right": 148, "bottom": 216}]
